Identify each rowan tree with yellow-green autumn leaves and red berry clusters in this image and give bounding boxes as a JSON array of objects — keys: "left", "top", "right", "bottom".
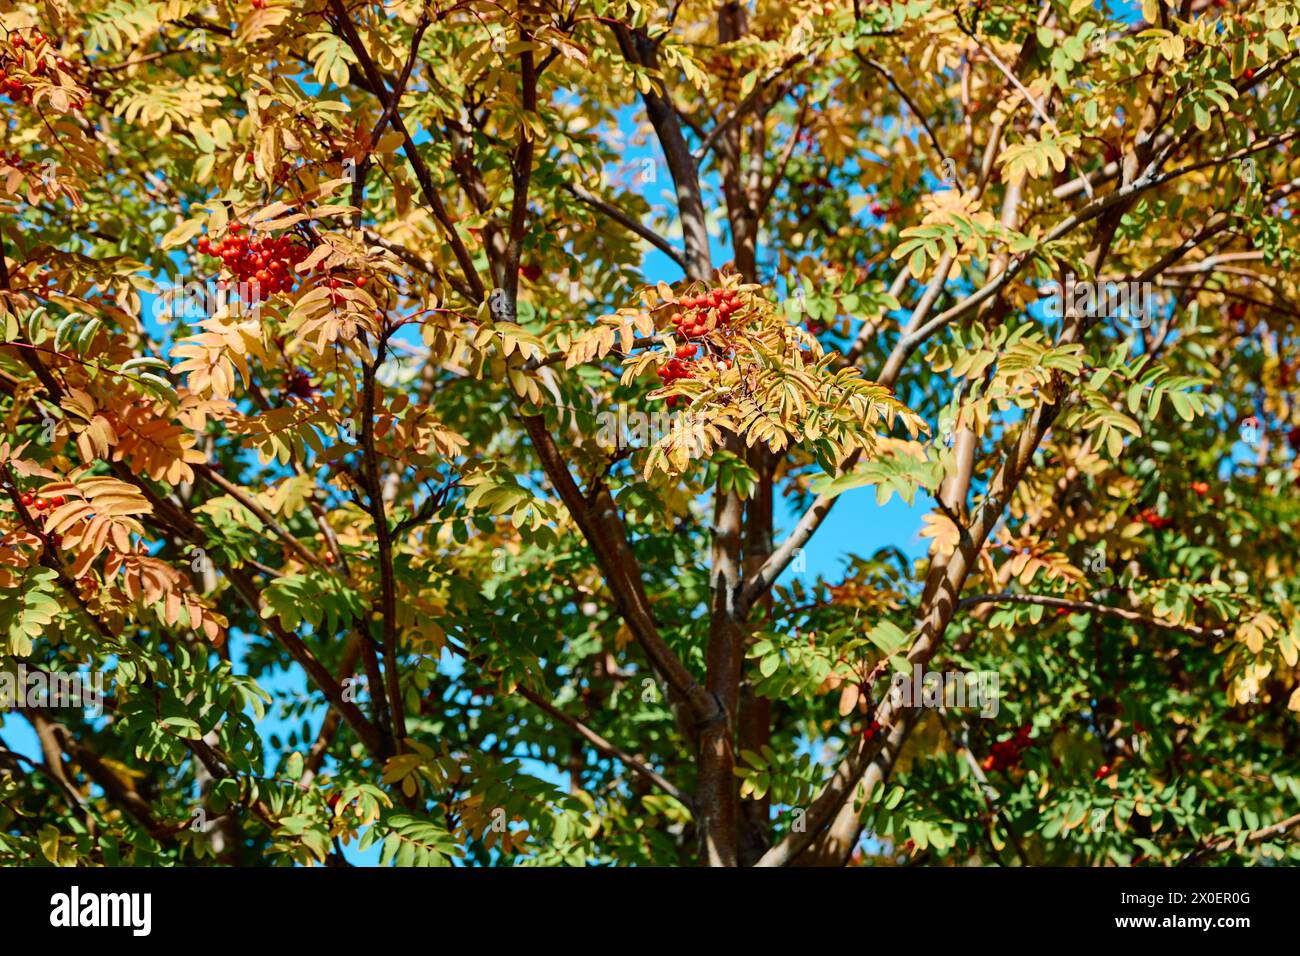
[{"left": 0, "top": 0, "right": 1300, "bottom": 865}]
